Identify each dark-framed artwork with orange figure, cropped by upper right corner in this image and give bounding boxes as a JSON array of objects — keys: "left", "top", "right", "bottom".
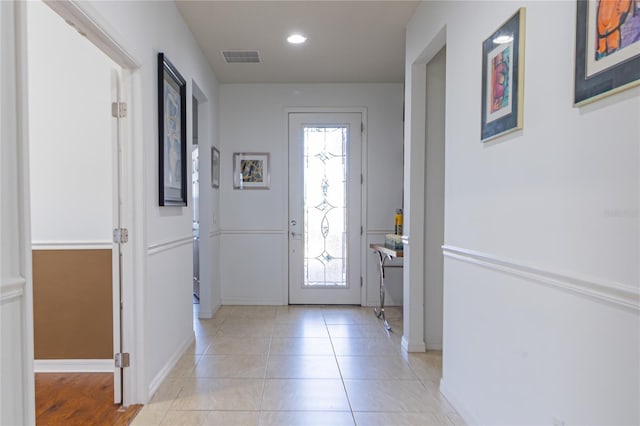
[{"left": 574, "top": 0, "right": 640, "bottom": 105}]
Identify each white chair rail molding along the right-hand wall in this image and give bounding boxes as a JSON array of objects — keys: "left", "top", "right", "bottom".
[{"left": 442, "top": 245, "right": 640, "bottom": 311}]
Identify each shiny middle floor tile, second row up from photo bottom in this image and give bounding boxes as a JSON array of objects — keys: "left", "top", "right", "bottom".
[{"left": 261, "top": 379, "right": 349, "bottom": 411}]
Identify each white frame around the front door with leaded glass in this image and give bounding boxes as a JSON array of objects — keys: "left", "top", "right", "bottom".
[{"left": 282, "top": 107, "right": 369, "bottom": 304}]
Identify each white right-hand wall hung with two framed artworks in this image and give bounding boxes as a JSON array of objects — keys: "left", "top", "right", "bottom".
[{"left": 406, "top": 1, "right": 640, "bottom": 424}]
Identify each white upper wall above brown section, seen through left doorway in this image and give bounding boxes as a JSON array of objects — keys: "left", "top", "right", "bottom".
[{"left": 27, "top": 2, "right": 119, "bottom": 247}]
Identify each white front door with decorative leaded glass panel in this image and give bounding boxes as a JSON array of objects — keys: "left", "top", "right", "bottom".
[{"left": 289, "top": 113, "right": 362, "bottom": 304}]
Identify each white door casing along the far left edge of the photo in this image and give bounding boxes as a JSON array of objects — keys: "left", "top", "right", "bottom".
[{"left": 0, "top": 1, "right": 35, "bottom": 425}]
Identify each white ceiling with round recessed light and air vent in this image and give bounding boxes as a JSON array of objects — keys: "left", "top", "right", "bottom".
[{"left": 176, "top": 0, "right": 419, "bottom": 83}]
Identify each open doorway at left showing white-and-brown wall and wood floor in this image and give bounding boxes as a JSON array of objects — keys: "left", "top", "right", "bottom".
[{"left": 25, "top": 2, "right": 140, "bottom": 423}]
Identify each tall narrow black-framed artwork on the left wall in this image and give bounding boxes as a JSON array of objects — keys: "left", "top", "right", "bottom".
[{"left": 158, "top": 53, "right": 187, "bottom": 206}]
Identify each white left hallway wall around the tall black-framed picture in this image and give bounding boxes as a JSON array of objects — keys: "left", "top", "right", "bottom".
[{"left": 72, "top": 1, "right": 220, "bottom": 402}]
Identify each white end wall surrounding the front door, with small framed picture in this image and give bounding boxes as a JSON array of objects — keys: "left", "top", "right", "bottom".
[{"left": 220, "top": 84, "right": 403, "bottom": 305}]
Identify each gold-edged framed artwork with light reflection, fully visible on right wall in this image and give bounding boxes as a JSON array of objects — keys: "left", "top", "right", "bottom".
[{"left": 480, "top": 7, "right": 525, "bottom": 142}]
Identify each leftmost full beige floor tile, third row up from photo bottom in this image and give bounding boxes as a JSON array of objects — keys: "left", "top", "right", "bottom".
[{"left": 192, "top": 354, "right": 267, "bottom": 379}]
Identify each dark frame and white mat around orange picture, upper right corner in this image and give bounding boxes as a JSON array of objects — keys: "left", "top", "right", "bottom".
[{"left": 574, "top": 0, "right": 640, "bottom": 106}]
